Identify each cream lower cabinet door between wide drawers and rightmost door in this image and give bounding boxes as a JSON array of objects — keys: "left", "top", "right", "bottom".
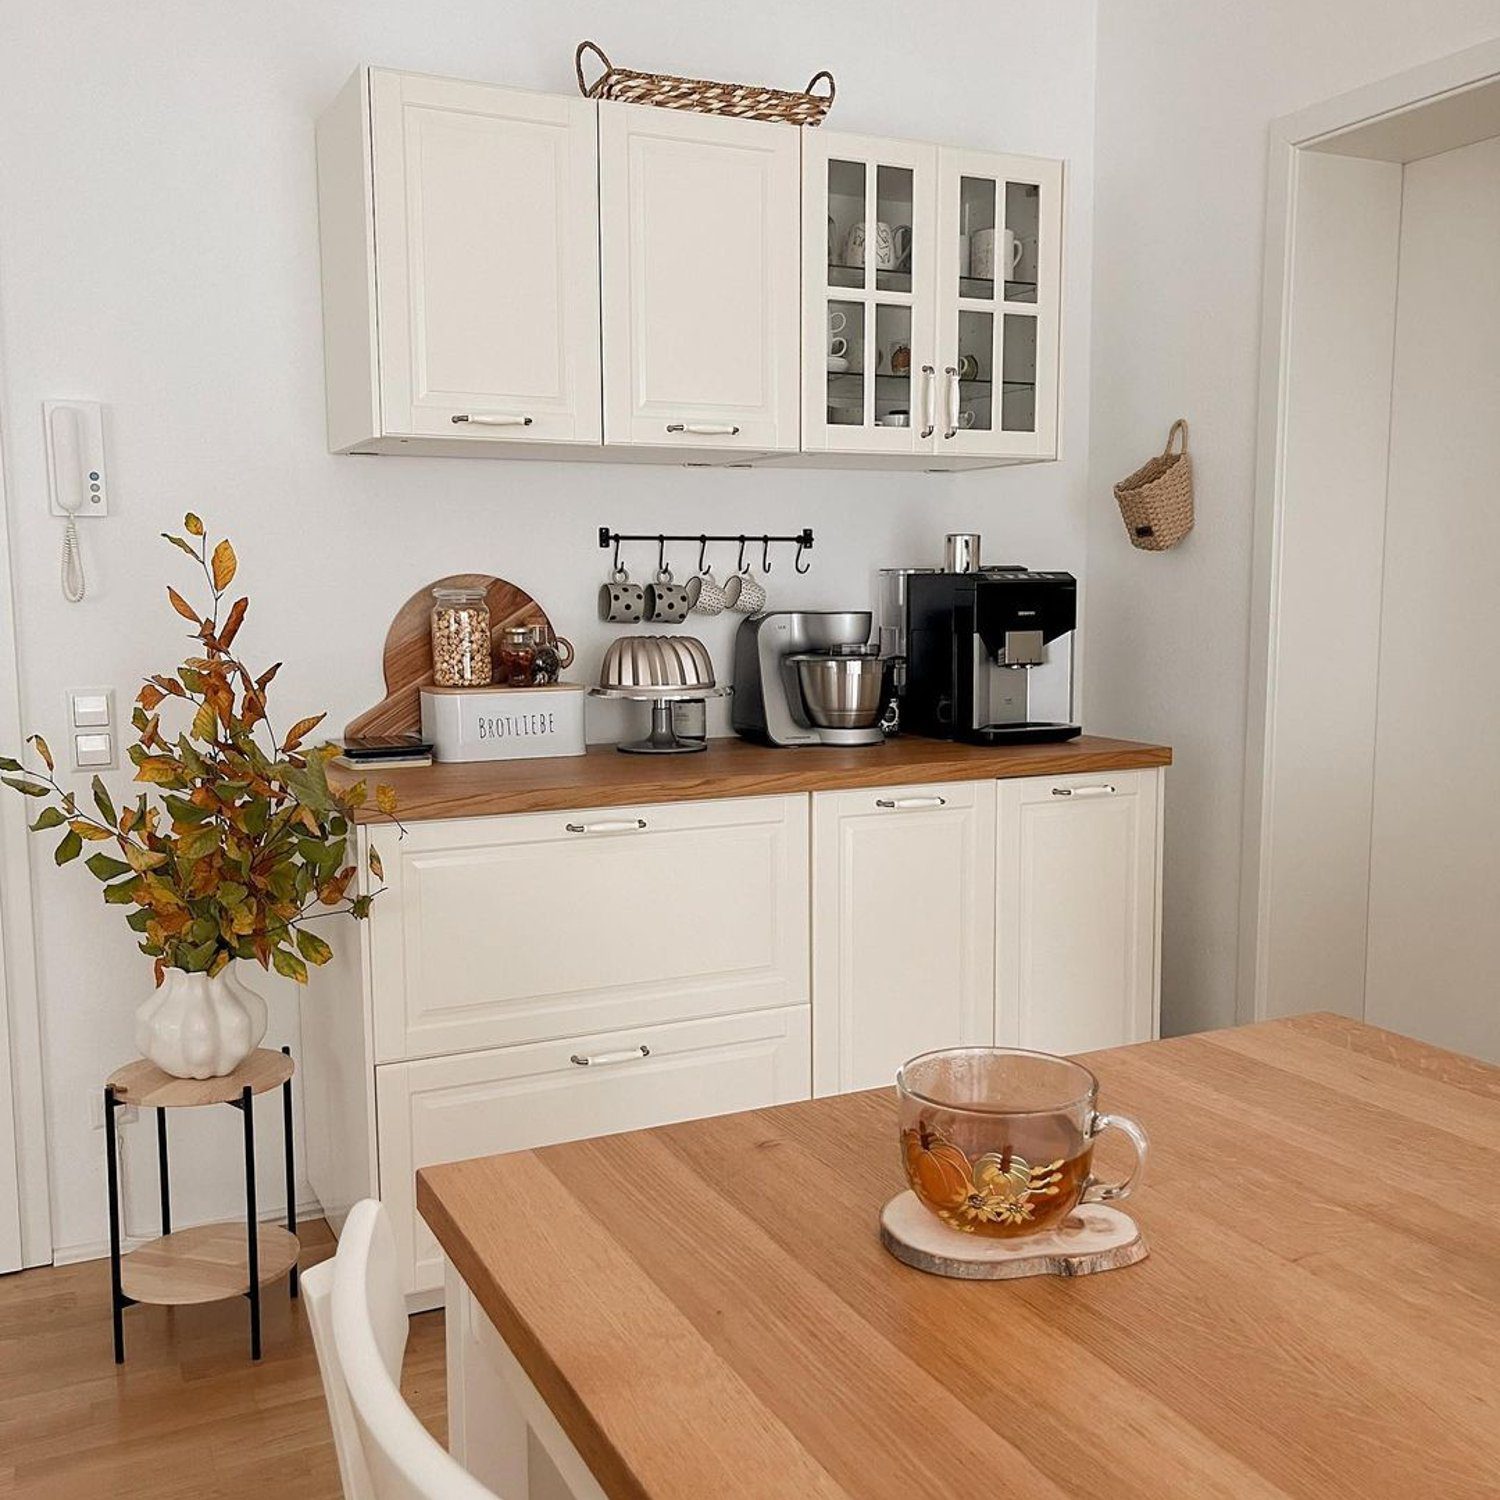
[{"left": 813, "top": 782, "right": 995, "bottom": 1094}]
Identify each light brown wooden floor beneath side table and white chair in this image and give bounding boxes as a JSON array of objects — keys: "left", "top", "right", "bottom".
[{"left": 0, "top": 1220, "right": 446, "bottom": 1500}]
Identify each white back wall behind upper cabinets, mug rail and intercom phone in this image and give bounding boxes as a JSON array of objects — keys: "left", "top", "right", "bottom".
[{"left": 0, "top": 0, "right": 1104, "bottom": 1251}]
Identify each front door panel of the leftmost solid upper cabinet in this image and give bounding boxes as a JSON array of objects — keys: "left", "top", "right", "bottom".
[{"left": 371, "top": 69, "right": 600, "bottom": 443}]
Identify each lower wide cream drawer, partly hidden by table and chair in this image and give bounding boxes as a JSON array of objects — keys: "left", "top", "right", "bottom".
[{"left": 375, "top": 1005, "right": 812, "bottom": 1295}]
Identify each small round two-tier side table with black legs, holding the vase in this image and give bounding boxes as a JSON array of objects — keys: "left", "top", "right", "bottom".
[{"left": 104, "top": 1047, "right": 300, "bottom": 1365}]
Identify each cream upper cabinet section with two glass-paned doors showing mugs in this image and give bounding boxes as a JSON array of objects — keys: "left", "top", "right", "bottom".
[{"left": 803, "top": 131, "right": 1062, "bottom": 468}]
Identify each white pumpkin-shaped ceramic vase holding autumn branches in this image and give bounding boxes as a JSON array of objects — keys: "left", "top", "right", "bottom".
[{"left": 135, "top": 963, "right": 266, "bottom": 1079}]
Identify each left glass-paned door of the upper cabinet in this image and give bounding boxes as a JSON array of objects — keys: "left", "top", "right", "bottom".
[{"left": 803, "top": 131, "right": 938, "bottom": 453}]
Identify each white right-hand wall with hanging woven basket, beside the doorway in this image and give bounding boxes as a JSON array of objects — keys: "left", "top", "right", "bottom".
[{"left": 1085, "top": 0, "right": 1500, "bottom": 1032}]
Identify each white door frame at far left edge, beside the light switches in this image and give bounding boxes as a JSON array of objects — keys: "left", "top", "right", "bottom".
[{"left": 0, "top": 289, "right": 53, "bottom": 1271}]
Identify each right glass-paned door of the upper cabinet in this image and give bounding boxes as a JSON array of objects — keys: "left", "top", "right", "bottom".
[{"left": 935, "top": 149, "right": 1062, "bottom": 459}]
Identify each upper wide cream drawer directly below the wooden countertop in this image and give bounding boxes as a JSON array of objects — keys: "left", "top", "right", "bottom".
[{"left": 371, "top": 797, "right": 809, "bottom": 1062}]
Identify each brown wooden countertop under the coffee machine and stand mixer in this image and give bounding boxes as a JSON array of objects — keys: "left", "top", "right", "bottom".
[{"left": 329, "top": 735, "right": 1172, "bottom": 822}]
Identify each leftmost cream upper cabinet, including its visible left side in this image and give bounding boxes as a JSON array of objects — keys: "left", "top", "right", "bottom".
[{"left": 318, "top": 69, "right": 600, "bottom": 452}]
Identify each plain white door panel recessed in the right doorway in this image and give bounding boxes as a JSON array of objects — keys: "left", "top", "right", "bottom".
[{"left": 1365, "top": 137, "right": 1500, "bottom": 1062}]
